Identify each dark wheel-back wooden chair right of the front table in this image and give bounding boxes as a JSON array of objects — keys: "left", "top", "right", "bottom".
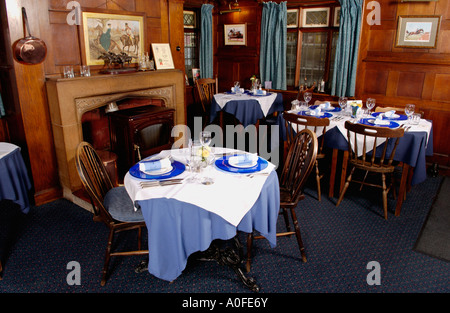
[{"left": 246, "top": 129, "right": 318, "bottom": 272}]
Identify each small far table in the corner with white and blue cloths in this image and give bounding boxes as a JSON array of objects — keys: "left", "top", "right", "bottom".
[{"left": 210, "top": 90, "right": 284, "bottom": 127}]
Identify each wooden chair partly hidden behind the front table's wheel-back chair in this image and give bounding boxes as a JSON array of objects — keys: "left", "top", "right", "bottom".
[{"left": 283, "top": 112, "right": 330, "bottom": 201}]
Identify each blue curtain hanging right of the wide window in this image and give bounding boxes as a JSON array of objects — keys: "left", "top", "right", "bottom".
[{"left": 331, "top": 0, "right": 364, "bottom": 97}]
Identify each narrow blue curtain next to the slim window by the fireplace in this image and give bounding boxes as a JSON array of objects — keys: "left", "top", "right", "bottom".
[{"left": 199, "top": 4, "right": 214, "bottom": 78}]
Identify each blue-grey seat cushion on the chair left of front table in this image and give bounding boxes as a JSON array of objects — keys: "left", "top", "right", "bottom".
[{"left": 103, "top": 186, "right": 144, "bottom": 222}]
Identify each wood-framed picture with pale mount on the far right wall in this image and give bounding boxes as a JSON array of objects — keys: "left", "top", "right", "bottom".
[{"left": 395, "top": 16, "right": 441, "bottom": 48}]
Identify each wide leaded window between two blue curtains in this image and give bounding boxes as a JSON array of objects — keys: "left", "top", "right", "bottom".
[{"left": 286, "top": 6, "right": 339, "bottom": 91}]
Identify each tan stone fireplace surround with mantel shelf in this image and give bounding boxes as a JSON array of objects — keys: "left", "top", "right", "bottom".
[{"left": 46, "top": 70, "right": 186, "bottom": 199}]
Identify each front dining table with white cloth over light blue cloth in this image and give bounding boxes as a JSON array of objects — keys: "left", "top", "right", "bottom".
[{"left": 124, "top": 147, "right": 280, "bottom": 289}]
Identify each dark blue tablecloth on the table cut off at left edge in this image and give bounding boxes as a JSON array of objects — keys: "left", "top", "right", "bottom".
[{"left": 0, "top": 143, "right": 31, "bottom": 214}]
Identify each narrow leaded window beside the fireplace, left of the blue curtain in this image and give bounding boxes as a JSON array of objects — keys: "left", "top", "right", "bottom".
[{"left": 183, "top": 11, "right": 200, "bottom": 80}]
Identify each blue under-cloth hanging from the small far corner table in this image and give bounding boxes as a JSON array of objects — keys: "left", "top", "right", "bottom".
[{"left": 210, "top": 93, "right": 284, "bottom": 127}]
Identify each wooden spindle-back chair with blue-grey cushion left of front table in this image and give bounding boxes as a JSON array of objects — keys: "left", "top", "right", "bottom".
[{"left": 75, "top": 142, "right": 148, "bottom": 286}]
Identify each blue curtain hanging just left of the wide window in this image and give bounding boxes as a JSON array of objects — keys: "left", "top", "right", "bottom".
[{"left": 259, "top": 1, "right": 287, "bottom": 90}]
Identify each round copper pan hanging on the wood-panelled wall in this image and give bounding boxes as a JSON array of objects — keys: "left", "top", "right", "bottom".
[{"left": 13, "top": 8, "right": 47, "bottom": 64}]
